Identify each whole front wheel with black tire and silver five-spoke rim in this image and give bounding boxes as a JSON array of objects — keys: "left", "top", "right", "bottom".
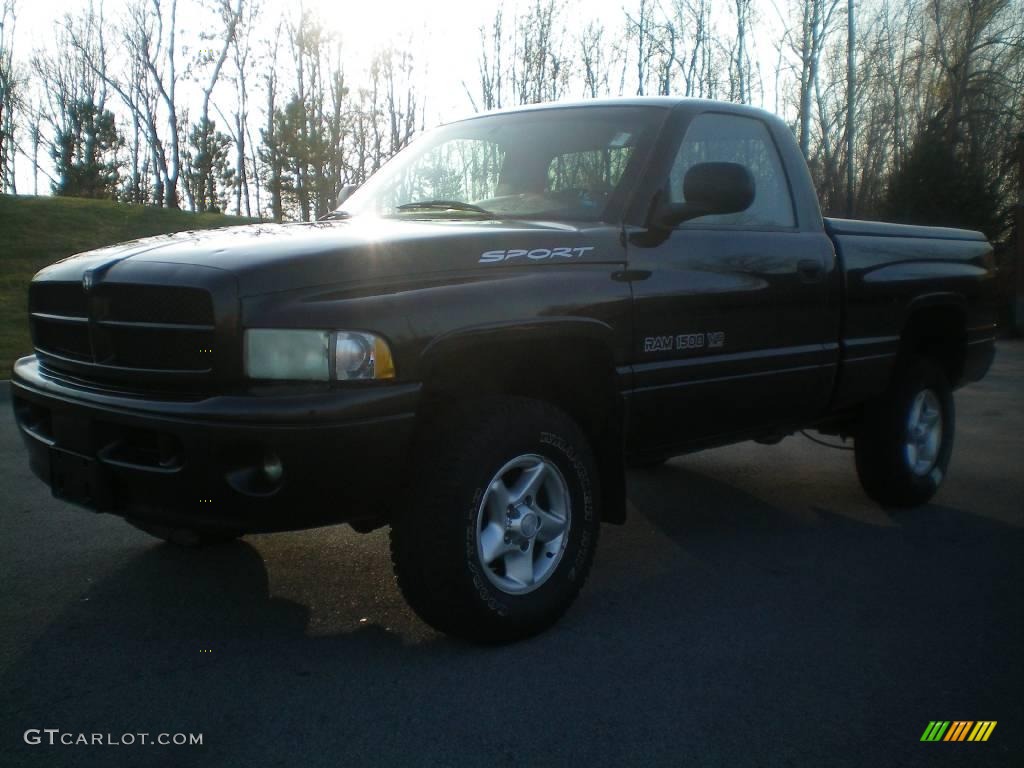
[{"left": 391, "top": 398, "right": 600, "bottom": 642}]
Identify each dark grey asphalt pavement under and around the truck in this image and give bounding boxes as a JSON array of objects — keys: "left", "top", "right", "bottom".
[{"left": 0, "top": 341, "right": 1024, "bottom": 768}]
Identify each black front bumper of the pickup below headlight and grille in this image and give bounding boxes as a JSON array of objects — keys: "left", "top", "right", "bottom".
[{"left": 11, "top": 356, "right": 420, "bottom": 532}]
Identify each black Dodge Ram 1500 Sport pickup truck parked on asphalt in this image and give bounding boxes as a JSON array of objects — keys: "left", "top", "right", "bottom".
[{"left": 12, "top": 98, "right": 995, "bottom": 641}]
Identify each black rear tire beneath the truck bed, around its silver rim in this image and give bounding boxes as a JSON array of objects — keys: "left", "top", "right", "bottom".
[{"left": 854, "top": 357, "right": 955, "bottom": 507}]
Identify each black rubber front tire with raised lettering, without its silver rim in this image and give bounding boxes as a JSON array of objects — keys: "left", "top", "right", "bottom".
[{"left": 390, "top": 397, "right": 600, "bottom": 643}]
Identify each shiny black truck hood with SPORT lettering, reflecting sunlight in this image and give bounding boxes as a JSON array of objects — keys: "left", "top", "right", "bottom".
[{"left": 37, "top": 217, "right": 625, "bottom": 297}]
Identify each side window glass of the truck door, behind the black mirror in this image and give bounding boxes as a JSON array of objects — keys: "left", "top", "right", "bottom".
[{"left": 669, "top": 113, "right": 796, "bottom": 227}]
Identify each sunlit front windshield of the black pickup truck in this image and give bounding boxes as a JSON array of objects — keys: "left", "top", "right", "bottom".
[{"left": 343, "top": 106, "right": 666, "bottom": 221}]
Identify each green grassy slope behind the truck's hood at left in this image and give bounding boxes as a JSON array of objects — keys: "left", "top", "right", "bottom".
[{"left": 0, "top": 195, "right": 251, "bottom": 379}]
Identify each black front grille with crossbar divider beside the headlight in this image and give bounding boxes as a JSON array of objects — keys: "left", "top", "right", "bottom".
[{"left": 29, "top": 282, "right": 216, "bottom": 380}]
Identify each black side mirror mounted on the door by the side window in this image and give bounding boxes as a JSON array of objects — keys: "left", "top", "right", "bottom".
[{"left": 654, "top": 163, "right": 755, "bottom": 227}]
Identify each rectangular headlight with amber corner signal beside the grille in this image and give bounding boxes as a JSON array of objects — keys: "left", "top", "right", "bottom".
[{"left": 245, "top": 328, "right": 394, "bottom": 381}]
